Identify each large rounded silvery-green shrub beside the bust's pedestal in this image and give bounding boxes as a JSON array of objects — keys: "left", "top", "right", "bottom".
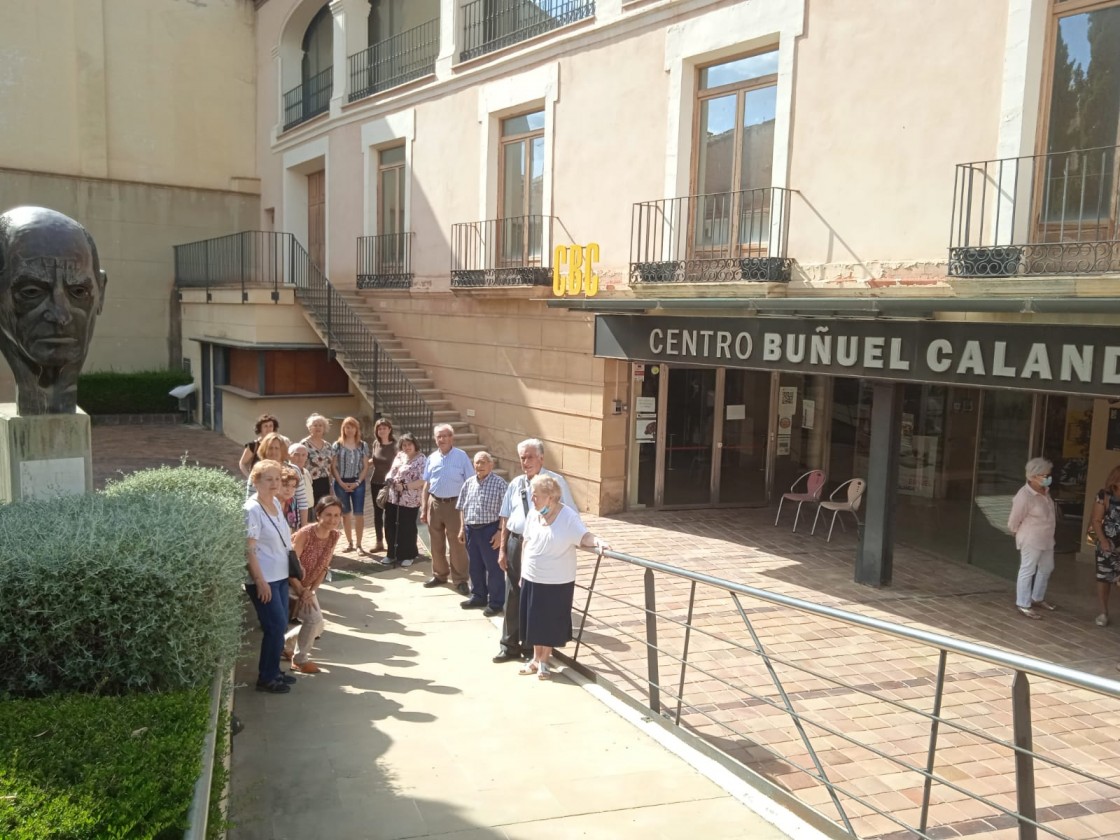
[{"left": 0, "top": 467, "right": 245, "bottom": 696}]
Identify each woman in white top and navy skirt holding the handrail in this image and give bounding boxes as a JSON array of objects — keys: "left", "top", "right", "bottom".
[{"left": 521, "top": 475, "right": 610, "bottom": 680}]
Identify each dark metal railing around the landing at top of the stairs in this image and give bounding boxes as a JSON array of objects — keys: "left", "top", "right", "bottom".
[{"left": 175, "top": 231, "right": 292, "bottom": 301}]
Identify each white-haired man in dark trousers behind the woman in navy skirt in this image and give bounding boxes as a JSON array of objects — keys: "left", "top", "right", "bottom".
[{"left": 456, "top": 452, "right": 506, "bottom": 618}]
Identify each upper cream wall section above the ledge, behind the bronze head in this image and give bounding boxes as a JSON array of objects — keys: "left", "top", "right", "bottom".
[{"left": 0, "top": 0, "right": 256, "bottom": 192}]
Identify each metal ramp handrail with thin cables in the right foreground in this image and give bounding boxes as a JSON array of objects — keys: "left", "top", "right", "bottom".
[{"left": 572, "top": 550, "right": 1120, "bottom": 840}]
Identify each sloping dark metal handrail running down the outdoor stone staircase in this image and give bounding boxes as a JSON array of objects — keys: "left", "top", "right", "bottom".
[{"left": 290, "top": 237, "right": 433, "bottom": 440}]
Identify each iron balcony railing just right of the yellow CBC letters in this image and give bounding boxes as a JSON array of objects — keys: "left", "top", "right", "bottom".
[{"left": 631, "top": 187, "right": 793, "bottom": 283}]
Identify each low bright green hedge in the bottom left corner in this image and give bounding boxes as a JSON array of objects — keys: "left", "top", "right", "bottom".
[{"left": 0, "top": 688, "right": 209, "bottom": 840}]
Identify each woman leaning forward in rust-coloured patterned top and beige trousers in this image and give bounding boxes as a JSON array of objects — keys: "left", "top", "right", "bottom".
[{"left": 284, "top": 496, "right": 343, "bottom": 674}]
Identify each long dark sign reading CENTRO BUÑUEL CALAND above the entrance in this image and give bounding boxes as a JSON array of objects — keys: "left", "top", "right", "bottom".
[{"left": 595, "top": 315, "right": 1120, "bottom": 396}]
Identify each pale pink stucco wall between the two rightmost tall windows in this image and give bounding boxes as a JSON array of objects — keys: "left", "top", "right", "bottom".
[{"left": 790, "top": 0, "right": 1007, "bottom": 279}]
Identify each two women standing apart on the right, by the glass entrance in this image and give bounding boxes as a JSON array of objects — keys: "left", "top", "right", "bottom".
[{"left": 1007, "top": 458, "right": 1120, "bottom": 627}]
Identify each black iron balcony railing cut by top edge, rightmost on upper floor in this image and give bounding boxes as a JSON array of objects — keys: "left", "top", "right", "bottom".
[{"left": 459, "top": 0, "right": 595, "bottom": 62}]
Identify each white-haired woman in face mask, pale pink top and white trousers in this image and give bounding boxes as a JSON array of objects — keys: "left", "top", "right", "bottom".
[{"left": 1007, "top": 458, "right": 1057, "bottom": 618}]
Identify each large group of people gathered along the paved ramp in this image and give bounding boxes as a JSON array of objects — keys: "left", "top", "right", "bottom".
[{"left": 240, "top": 414, "right": 609, "bottom": 693}]
